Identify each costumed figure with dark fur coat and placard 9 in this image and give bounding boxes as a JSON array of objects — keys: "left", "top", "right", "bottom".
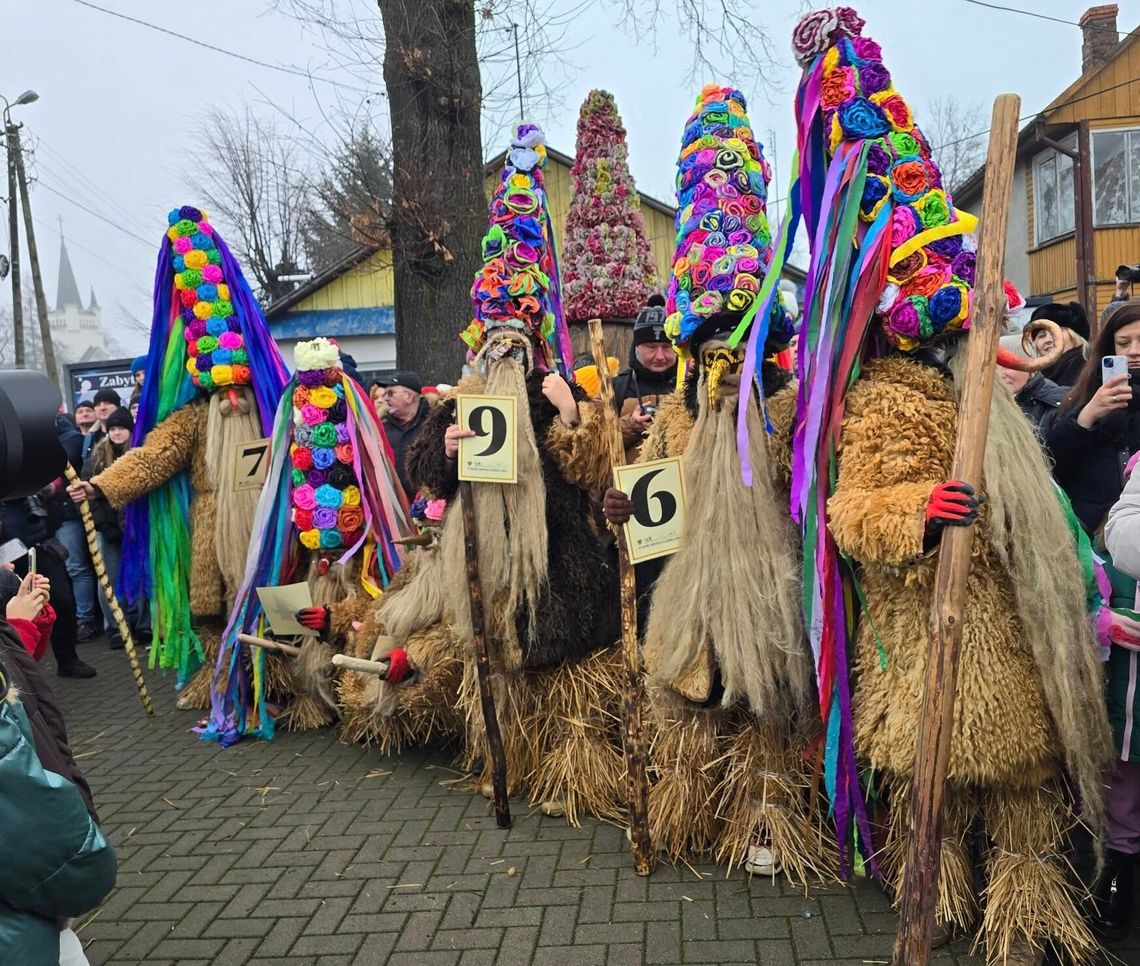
[{"left": 345, "top": 125, "right": 625, "bottom": 822}]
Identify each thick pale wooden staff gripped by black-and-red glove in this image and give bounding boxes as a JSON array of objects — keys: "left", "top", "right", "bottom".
[{"left": 894, "top": 94, "right": 1021, "bottom": 966}]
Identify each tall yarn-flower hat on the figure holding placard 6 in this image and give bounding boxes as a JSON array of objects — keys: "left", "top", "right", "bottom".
[{"left": 666, "top": 84, "right": 793, "bottom": 355}]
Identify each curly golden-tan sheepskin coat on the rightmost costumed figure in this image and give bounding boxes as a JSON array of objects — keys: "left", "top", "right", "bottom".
[{"left": 828, "top": 356, "right": 1064, "bottom": 788}]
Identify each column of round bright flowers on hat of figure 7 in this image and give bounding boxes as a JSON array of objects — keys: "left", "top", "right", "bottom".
[{"left": 166, "top": 205, "right": 253, "bottom": 392}]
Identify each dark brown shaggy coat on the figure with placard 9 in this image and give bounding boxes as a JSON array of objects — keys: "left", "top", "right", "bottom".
[{"left": 406, "top": 370, "right": 620, "bottom": 671}]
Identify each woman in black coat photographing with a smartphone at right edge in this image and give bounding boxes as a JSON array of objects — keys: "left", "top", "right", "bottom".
[{"left": 1045, "top": 301, "right": 1140, "bottom": 534}]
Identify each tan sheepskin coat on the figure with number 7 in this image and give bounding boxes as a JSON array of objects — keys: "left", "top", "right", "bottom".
[{"left": 91, "top": 399, "right": 228, "bottom": 618}]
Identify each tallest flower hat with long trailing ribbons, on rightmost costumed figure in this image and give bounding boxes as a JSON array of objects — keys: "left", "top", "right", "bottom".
[{"left": 788, "top": 7, "right": 976, "bottom": 874}]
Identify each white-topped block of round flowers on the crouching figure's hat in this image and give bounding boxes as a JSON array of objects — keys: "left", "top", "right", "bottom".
[{"left": 290, "top": 339, "right": 365, "bottom": 553}]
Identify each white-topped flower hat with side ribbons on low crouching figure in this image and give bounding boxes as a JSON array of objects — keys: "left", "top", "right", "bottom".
[{"left": 202, "top": 339, "right": 415, "bottom": 746}]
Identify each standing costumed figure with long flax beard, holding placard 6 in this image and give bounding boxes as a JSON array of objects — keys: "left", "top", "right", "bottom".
[{"left": 604, "top": 86, "right": 834, "bottom": 883}]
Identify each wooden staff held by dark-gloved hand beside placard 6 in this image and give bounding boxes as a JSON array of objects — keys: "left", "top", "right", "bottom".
[{"left": 589, "top": 318, "right": 653, "bottom": 876}]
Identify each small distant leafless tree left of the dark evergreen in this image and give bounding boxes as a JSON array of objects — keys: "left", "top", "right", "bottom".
[{"left": 186, "top": 105, "right": 311, "bottom": 303}]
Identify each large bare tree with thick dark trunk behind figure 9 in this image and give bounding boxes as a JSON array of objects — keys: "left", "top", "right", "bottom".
[{"left": 270, "top": 0, "right": 774, "bottom": 380}]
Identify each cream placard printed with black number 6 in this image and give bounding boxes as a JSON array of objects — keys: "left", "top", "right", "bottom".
[{"left": 613, "top": 458, "right": 685, "bottom": 563}]
